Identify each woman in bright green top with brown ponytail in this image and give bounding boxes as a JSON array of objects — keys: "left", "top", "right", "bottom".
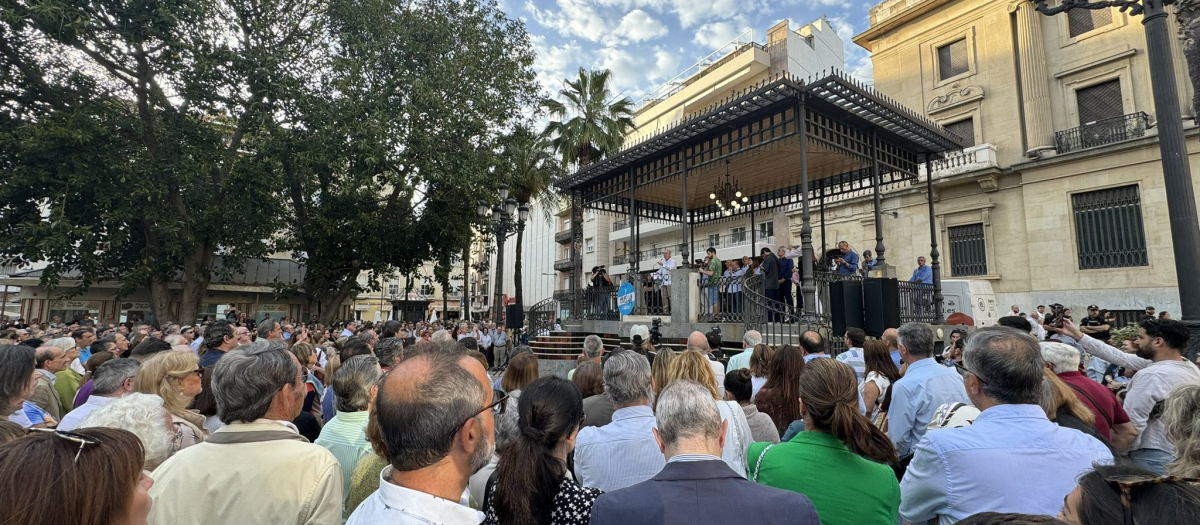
[{"left": 746, "top": 360, "right": 900, "bottom": 525}]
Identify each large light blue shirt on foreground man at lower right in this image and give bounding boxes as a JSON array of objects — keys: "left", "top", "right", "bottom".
[{"left": 893, "top": 405, "right": 1112, "bottom": 525}]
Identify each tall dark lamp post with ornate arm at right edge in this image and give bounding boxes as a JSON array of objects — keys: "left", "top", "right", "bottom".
[{"left": 1034, "top": 0, "right": 1200, "bottom": 357}]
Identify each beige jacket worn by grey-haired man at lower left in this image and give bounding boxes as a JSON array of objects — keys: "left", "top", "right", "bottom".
[{"left": 149, "top": 420, "right": 342, "bottom": 525}]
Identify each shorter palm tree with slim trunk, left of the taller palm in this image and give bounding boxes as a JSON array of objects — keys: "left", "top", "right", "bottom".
[{"left": 504, "top": 125, "right": 560, "bottom": 306}]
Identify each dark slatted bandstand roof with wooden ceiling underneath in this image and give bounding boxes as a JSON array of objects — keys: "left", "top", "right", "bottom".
[{"left": 556, "top": 72, "right": 962, "bottom": 224}]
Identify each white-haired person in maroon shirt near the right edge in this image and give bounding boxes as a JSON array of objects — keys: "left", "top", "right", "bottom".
[{"left": 1041, "top": 340, "right": 1138, "bottom": 452}]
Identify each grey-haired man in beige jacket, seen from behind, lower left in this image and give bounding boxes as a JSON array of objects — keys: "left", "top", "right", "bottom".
[{"left": 150, "top": 339, "right": 343, "bottom": 525}]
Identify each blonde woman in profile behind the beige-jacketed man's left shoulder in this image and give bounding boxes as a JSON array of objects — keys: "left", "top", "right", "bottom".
[{"left": 133, "top": 351, "right": 208, "bottom": 454}]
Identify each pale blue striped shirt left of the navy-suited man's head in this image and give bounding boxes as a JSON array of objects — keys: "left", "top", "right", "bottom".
[{"left": 575, "top": 405, "right": 666, "bottom": 493}]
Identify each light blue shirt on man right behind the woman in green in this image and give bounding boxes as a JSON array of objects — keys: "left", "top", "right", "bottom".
[{"left": 888, "top": 357, "right": 969, "bottom": 455}]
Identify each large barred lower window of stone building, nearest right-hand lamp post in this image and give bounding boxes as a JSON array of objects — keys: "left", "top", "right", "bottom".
[{"left": 1070, "top": 185, "right": 1150, "bottom": 270}]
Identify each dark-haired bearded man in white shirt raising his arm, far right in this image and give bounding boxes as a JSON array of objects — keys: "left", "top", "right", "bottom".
[{"left": 1061, "top": 319, "right": 1200, "bottom": 475}]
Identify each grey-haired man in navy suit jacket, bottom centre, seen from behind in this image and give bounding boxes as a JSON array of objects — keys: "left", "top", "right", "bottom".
[{"left": 592, "top": 380, "right": 821, "bottom": 525}]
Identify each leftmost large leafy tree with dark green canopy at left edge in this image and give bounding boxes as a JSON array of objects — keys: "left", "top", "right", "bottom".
[{"left": 0, "top": 0, "right": 292, "bottom": 322}]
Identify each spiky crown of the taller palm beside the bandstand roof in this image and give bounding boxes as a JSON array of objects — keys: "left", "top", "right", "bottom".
[{"left": 541, "top": 67, "right": 634, "bottom": 168}]
